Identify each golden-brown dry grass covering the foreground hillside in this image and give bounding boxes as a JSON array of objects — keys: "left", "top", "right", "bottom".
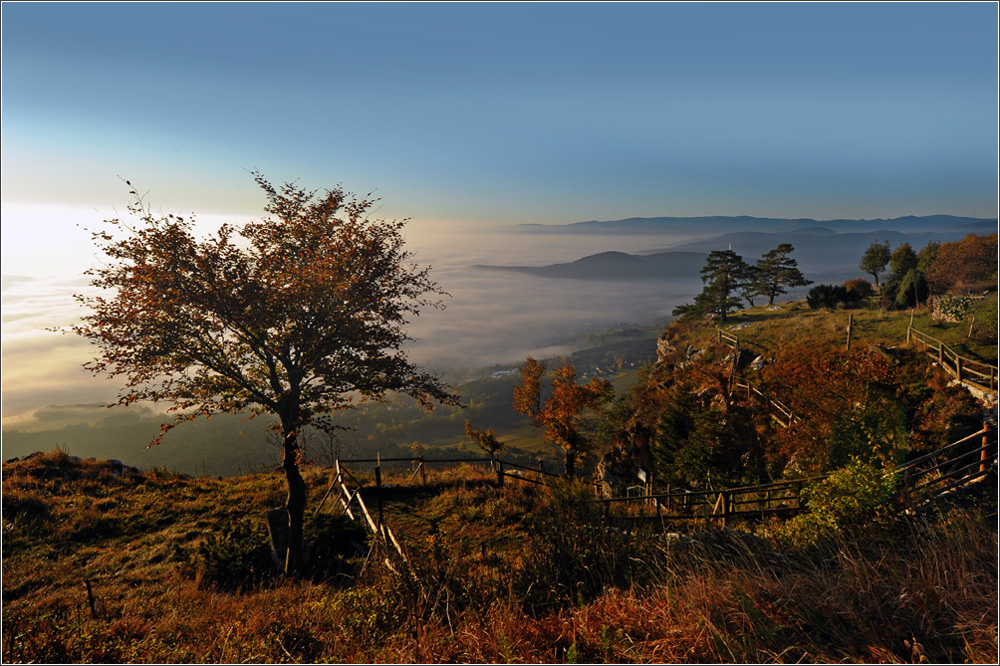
[{"left": 3, "top": 453, "right": 997, "bottom": 663}]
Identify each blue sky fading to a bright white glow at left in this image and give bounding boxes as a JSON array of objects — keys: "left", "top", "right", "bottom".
[{"left": 0, "top": 2, "right": 998, "bottom": 426}]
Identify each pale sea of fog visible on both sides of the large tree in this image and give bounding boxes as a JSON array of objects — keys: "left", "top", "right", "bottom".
[{"left": 2, "top": 208, "right": 700, "bottom": 427}]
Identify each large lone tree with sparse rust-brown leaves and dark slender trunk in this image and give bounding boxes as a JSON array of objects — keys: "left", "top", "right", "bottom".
[{"left": 72, "top": 172, "right": 457, "bottom": 575}]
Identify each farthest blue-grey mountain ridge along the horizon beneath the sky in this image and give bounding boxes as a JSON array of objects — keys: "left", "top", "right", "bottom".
[{"left": 512, "top": 215, "right": 997, "bottom": 234}]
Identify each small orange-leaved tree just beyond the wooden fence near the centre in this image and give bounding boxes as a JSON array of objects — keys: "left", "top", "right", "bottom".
[{"left": 514, "top": 356, "right": 614, "bottom": 478}]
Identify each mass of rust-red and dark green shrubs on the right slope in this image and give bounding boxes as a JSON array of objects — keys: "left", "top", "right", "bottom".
[{"left": 616, "top": 306, "right": 983, "bottom": 490}]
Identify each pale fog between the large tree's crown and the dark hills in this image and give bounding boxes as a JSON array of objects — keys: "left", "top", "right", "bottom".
[{"left": 398, "top": 224, "right": 701, "bottom": 370}]
